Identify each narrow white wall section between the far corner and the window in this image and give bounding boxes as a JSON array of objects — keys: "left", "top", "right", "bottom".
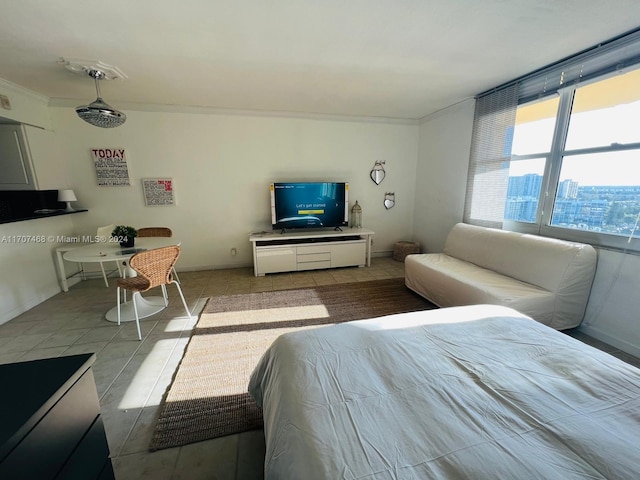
[{"left": 413, "top": 99, "right": 475, "bottom": 252}]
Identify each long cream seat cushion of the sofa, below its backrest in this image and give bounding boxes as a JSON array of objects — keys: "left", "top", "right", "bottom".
[{"left": 405, "top": 253, "right": 555, "bottom": 325}]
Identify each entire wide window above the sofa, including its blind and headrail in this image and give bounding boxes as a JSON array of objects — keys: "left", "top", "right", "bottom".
[{"left": 464, "top": 31, "right": 640, "bottom": 252}]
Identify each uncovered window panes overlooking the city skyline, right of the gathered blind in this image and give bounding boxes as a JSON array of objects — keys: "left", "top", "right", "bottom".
[{"left": 504, "top": 69, "right": 640, "bottom": 246}]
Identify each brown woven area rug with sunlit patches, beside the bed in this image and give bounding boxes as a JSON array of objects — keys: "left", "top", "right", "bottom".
[{"left": 150, "top": 278, "right": 435, "bottom": 450}]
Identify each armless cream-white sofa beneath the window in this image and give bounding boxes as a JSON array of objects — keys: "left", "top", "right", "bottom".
[{"left": 405, "top": 223, "right": 597, "bottom": 330}]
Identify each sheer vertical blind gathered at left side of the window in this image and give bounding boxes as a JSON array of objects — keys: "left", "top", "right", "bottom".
[{"left": 463, "top": 83, "right": 518, "bottom": 228}]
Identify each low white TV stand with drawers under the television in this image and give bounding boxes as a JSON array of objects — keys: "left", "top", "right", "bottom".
[{"left": 249, "top": 227, "right": 374, "bottom": 277}]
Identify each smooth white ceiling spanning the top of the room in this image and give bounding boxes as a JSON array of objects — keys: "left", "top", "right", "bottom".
[{"left": 0, "top": 0, "right": 640, "bottom": 120}]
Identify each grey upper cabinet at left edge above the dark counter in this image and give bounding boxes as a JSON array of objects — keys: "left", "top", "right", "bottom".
[{"left": 0, "top": 125, "right": 38, "bottom": 190}]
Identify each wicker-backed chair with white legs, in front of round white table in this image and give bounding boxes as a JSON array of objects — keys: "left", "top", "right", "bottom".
[{"left": 116, "top": 245, "right": 191, "bottom": 340}]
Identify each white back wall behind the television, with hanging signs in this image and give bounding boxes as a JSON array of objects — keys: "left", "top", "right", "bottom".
[{"left": 51, "top": 107, "right": 418, "bottom": 270}]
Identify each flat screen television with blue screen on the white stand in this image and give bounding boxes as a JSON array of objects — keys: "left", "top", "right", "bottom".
[{"left": 271, "top": 182, "right": 349, "bottom": 230}]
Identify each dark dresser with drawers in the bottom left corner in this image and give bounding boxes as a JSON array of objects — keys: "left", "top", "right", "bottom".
[{"left": 0, "top": 354, "right": 114, "bottom": 480}]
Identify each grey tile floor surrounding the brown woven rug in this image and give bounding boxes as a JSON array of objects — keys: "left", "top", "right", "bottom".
[{"left": 0, "top": 257, "right": 640, "bottom": 480}]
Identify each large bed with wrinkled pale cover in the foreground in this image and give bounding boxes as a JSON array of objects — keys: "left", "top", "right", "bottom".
[{"left": 249, "top": 305, "right": 640, "bottom": 479}]
